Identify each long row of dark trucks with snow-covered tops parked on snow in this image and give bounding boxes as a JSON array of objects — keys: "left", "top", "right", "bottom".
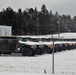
[{"left": 0, "top": 33, "right": 76, "bottom": 56}]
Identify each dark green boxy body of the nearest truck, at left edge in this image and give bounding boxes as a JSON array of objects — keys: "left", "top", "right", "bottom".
[{"left": 0, "top": 36, "right": 18, "bottom": 54}]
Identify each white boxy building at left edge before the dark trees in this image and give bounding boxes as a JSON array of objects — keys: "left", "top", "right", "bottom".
[{"left": 0, "top": 25, "right": 12, "bottom": 36}]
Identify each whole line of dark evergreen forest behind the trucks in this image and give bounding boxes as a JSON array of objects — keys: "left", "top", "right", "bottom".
[{"left": 0, "top": 4, "right": 76, "bottom": 35}]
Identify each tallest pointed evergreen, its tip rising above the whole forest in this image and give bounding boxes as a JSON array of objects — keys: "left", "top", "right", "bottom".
[{"left": 39, "top": 4, "right": 48, "bottom": 35}]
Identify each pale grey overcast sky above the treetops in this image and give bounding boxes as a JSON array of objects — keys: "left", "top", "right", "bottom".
[{"left": 0, "top": 0, "right": 76, "bottom": 16}]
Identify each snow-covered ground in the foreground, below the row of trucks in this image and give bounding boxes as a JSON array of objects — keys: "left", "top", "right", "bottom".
[{"left": 0, "top": 50, "right": 76, "bottom": 75}]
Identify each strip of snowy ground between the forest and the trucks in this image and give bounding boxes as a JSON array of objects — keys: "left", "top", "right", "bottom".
[{"left": 17, "top": 32, "right": 76, "bottom": 38}]
